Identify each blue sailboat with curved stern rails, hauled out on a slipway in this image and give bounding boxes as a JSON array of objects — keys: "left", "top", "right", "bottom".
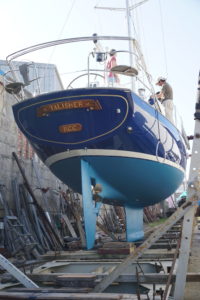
[{"left": 7, "top": 1, "right": 186, "bottom": 249}]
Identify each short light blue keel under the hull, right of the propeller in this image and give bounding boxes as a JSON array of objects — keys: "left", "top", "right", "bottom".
[{"left": 125, "top": 206, "right": 144, "bottom": 242}]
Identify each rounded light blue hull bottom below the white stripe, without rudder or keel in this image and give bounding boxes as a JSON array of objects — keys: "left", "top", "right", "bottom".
[{"left": 50, "top": 150, "right": 184, "bottom": 208}]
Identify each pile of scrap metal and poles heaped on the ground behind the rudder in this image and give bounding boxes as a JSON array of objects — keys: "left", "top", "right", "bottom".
[{"left": 0, "top": 153, "right": 128, "bottom": 260}]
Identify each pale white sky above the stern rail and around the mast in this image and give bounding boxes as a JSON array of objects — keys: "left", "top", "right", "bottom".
[{"left": 0, "top": 0, "right": 200, "bottom": 135}]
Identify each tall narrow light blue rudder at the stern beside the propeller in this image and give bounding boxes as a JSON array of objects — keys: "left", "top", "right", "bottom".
[{"left": 81, "top": 159, "right": 102, "bottom": 249}]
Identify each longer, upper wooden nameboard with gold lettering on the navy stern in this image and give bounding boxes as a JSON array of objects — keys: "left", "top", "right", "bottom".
[{"left": 37, "top": 99, "right": 102, "bottom": 117}]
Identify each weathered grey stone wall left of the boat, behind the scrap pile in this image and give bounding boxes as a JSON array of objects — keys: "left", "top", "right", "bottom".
[{"left": 0, "top": 86, "right": 67, "bottom": 215}]
